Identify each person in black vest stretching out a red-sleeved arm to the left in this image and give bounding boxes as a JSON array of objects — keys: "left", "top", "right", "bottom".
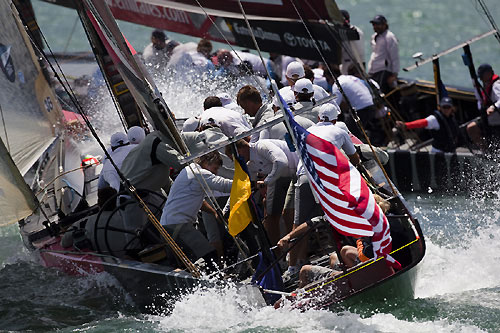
[{"left": 396, "top": 97, "right": 459, "bottom": 153}]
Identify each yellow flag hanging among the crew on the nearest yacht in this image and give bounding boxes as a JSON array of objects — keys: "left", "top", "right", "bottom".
[{"left": 228, "top": 159, "right": 252, "bottom": 236}]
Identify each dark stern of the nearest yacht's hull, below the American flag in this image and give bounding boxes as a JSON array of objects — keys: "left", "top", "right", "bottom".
[{"left": 278, "top": 161, "right": 425, "bottom": 309}]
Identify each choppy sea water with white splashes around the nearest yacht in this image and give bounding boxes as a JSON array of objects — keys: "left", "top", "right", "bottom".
[{"left": 0, "top": 0, "right": 500, "bottom": 332}]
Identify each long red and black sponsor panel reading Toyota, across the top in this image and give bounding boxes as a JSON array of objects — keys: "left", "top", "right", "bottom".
[{"left": 44, "top": 0, "right": 359, "bottom": 63}]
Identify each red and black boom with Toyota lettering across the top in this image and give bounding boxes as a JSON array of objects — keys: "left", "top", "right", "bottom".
[{"left": 44, "top": 0, "right": 359, "bottom": 62}]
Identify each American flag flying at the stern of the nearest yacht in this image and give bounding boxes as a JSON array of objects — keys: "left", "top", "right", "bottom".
[{"left": 280, "top": 92, "right": 401, "bottom": 268}]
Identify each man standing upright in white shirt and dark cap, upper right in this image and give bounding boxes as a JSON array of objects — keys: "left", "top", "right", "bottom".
[{"left": 368, "top": 15, "right": 399, "bottom": 94}]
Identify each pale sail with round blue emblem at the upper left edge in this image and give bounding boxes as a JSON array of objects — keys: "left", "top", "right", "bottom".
[{"left": 0, "top": 0, "right": 61, "bottom": 176}]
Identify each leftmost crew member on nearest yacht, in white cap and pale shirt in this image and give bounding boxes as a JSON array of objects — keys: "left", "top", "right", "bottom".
[{"left": 97, "top": 132, "right": 133, "bottom": 192}]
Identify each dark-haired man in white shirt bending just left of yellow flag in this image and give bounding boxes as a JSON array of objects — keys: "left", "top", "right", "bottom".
[{"left": 160, "top": 151, "right": 232, "bottom": 267}]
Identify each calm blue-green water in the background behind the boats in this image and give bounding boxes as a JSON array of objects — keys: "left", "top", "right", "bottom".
[{"left": 33, "top": 0, "right": 500, "bottom": 87}]
